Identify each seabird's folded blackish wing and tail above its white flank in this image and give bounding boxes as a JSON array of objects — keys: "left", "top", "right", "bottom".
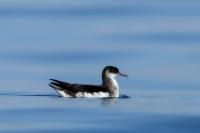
[{"left": 49, "top": 79, "right": 109, "bottom": 96}]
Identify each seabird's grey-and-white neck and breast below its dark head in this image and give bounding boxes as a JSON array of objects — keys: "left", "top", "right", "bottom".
[{"left": 103, "top": 76, "right": 119, "bottom": 97}]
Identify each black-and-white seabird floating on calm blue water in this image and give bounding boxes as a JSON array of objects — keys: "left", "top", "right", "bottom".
[{"left": 49, "top": 66, "right": 128, "bottom": 98}]
